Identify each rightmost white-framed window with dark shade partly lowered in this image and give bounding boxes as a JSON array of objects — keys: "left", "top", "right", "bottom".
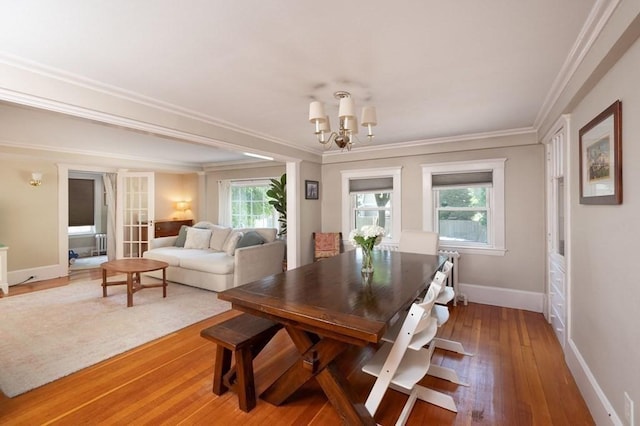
[{"left": 422, "top": 159, "right": 505, "bottom": 255}]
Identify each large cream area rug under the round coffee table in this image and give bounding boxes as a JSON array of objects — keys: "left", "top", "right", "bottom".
[{"left": 0, "top": 276, "right": 231, "bottom": 397}]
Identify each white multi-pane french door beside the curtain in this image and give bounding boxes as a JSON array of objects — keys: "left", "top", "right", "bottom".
[{"left": 116, "top": 172, "right": 154, "bottom": 259}]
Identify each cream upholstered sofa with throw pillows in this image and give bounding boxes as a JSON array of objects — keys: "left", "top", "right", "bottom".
[{"left": 142, "top": 222, "right": 285, "bottom": 291}]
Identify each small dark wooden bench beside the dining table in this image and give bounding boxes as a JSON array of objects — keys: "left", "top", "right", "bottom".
[{"left": 200, "top": 313, "right": 282, "bottom": 412}]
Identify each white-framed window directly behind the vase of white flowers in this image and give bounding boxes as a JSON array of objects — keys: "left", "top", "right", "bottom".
[{"left": 342, "top": 168, "right": 401, "bottom": 244}]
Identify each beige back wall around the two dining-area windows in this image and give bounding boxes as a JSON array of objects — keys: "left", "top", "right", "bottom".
[{"left": 322, "top": 138, "right": 545, "bottom": 293}]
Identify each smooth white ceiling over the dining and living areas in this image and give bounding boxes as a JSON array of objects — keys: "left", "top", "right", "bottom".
[{"left": 0, "top": 0, "right": 595, "bottom": 163}]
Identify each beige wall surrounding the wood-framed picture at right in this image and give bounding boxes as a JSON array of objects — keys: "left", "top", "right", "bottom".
[{"left": 569, "top": 34, "right": 640, "bottom": 421}]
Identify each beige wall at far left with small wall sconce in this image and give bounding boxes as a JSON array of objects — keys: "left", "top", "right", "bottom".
[{"left": 0, "top": 153, "right": 58, "bottom": 271}]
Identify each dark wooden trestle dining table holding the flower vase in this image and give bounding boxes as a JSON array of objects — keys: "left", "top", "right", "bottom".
[{"left": 218, "top": 249, "right": 445, "bottom": 424}]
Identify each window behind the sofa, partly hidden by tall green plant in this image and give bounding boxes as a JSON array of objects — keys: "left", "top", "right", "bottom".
[{"left": 230, "top": 180, "right": 278, "bottom": 228}]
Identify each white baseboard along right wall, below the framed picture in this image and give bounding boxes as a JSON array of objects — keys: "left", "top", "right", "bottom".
[{"left": 564, "top": 339, "right": 623, "bottom": 426}]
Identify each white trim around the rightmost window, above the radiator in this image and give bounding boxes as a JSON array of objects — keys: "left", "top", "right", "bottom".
[{"left": 421, "top": 158, "right": 507, "bottom": 256}]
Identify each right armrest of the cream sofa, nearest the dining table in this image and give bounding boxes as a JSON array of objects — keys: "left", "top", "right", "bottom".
[{"left": 233, "top": 240, "right": 286, "bottom": 287}]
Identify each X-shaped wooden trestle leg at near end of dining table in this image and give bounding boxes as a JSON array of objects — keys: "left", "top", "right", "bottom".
[{"left": 260, "top": 326, "right": 376, "bottom": 425}]
